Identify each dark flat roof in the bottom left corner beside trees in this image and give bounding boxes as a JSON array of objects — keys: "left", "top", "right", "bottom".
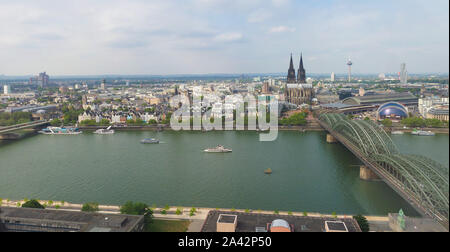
[{"left": 0, "top": 207, "right": 144, "bottom": 232}]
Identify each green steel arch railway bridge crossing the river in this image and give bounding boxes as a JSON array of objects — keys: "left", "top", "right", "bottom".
[{"left": 319, "top": 114, "right": 449, "bottom": 225}]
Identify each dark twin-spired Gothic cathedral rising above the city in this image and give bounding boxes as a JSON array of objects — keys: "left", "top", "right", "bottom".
[{"left": 284, "top": 55, "right": 314, "bottom": 105}]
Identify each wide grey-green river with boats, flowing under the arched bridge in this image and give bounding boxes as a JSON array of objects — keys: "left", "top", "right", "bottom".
[{"left": 0, "top": 131, "right": 449, "bottom": 215}]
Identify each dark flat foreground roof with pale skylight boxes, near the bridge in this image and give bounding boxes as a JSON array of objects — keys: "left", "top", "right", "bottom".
[{"left": 202, "top": 211, "right": 361, "bottom": 232}]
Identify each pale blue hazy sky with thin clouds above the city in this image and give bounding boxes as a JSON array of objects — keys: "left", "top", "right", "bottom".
[{"left": 0, "top": 0, "right": 449, "bottom": 75}]
